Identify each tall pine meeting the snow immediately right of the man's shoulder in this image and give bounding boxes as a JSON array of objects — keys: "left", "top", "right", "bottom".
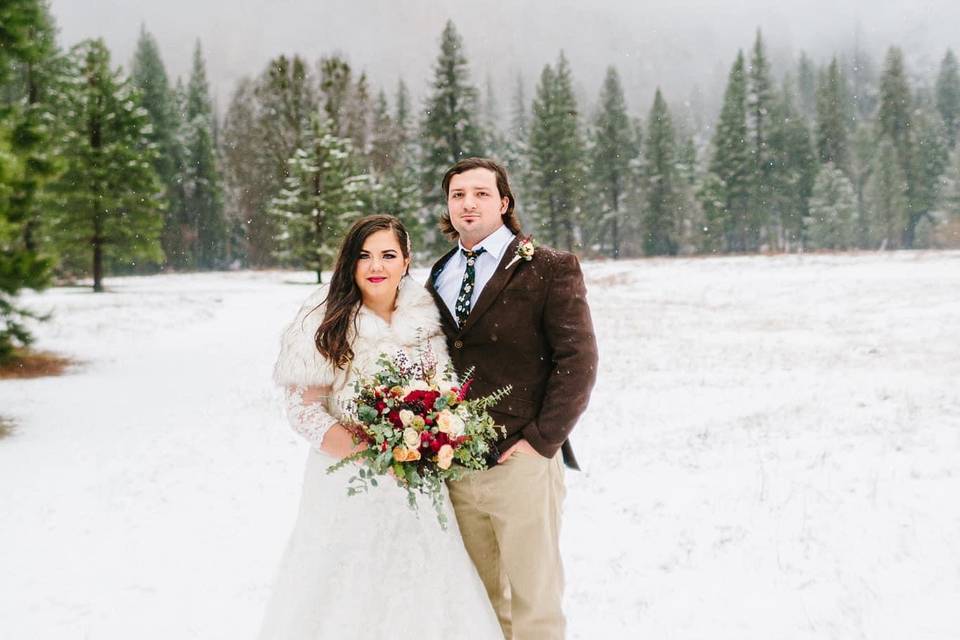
[{"left": 590, "top": 67, "right": 638, "bottom": 259}]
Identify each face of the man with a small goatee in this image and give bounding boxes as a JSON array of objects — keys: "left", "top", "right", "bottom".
[{"left": 447, "top": 168, "right": 510, "bottom": 249}]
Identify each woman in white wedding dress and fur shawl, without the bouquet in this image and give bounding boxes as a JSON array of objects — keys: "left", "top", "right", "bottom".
[{"left": 259, "top": 215, "right": 503, "bottom": 640}]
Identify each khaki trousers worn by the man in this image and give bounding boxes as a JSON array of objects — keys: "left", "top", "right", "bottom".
[{"left": 449, "top": 453, "right": 566, "bottom": 640}]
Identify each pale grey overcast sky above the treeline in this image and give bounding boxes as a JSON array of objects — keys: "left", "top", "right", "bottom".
[{"left": 51, "top": 0, "right": 960, "bottom": 120}]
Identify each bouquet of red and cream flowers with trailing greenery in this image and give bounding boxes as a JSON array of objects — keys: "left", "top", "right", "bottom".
[{"left": 327, "top": 349, "right": 511, "bottom": 528}]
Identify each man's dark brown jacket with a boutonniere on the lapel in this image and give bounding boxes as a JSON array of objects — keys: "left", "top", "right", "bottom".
[{"left": 427, "top": 236, "right": 597, "bottom": 469}]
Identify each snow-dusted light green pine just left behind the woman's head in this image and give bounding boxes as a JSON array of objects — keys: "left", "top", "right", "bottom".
[{"left": 270, "top": 117, "right": 369, "bottom": 283}]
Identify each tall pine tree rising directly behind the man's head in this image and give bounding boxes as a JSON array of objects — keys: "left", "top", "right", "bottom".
[{"left": 420, "top": 21, "right": 483, "bottom": 206}]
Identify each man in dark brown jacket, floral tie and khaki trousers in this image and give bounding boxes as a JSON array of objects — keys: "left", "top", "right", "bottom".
[{"left": 427, "top": 158, "right": 597, "bottom": 640}]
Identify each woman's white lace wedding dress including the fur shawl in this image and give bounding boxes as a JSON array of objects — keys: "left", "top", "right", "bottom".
[{"left": 259, "top": 281, "right": 503, "bottom": 640}]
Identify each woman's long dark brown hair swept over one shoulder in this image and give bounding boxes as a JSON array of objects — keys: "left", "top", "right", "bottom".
[{"left": 313, "top": 215, "right": 410, "bottom": 369}]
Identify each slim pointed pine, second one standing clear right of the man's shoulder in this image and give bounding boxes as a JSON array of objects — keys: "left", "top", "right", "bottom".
[{"left": 642, "top": 87, "right": 680, "bottom": 255}]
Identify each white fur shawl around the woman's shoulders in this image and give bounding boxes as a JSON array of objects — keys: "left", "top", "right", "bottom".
[{"left": 273, "top": 277, "right": 449, "bottom": 390}]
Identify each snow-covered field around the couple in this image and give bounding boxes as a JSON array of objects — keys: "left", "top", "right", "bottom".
[{"left": 0, "top": 252, "right": 960, "bottom": 640}]
